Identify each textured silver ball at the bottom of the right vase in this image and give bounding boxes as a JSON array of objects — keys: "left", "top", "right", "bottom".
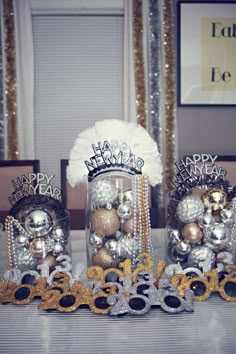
[{"left": 188, "top": 245, "right": 215, "bottom": 272}]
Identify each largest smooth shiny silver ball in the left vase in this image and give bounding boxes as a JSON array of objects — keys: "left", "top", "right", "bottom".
[{"left": 25, "top": 209, "right": 53, "bottom": 237}]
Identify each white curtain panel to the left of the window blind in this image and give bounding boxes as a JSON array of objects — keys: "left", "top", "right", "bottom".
[{"left": 14, "top": 0, "right": 35, "bottom": 160}]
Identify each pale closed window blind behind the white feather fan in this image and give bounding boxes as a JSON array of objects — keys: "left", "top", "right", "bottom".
[{"left": 32, "top": 15, "right": 123, "bottom": 185}]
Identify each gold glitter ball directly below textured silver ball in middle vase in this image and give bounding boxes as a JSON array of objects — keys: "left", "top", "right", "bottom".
[{"left": 92, "top": 208, "right": 120, "bottom": 236}]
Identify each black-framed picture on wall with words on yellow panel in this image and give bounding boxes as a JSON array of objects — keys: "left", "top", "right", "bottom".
[{"left": 178, "top": 1, "right": 236, "bottom": 106}]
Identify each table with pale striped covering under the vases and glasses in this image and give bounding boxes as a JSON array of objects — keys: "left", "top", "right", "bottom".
[{"left": 0, "top": 230, "right": 236, "bottom": 354}]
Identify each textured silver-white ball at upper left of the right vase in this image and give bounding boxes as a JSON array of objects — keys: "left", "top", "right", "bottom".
[{"left": 176, "top": 196, "right": 204, "bottom": 223}]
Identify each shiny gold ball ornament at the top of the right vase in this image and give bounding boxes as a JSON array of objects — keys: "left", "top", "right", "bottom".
[{"left": 202, "top": 189, "right": 227, "bottom": 213}]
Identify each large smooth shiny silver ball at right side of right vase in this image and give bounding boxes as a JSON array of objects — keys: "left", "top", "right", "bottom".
[{"left": 204, "top": 223, "right": 230, "bottom": 250}]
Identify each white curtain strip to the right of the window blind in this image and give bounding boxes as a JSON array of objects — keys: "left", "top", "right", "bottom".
[{"left": 124, "top": 0, "right": 137, "bottom": 123}]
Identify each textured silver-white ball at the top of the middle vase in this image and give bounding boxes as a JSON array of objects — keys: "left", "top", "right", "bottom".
[{"left": 90, "top": 180, "right": 118, "bottom": 208}]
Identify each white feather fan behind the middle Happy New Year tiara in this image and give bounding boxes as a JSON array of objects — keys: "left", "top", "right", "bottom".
[{"left": 67, "top": 119, "right": 162, "bottom": 187}]
